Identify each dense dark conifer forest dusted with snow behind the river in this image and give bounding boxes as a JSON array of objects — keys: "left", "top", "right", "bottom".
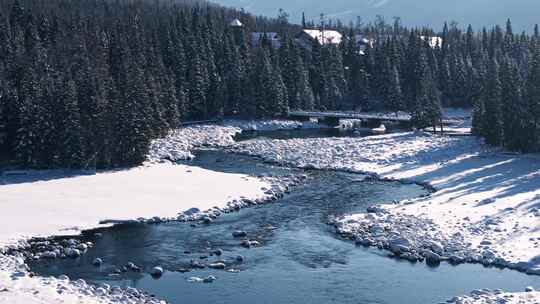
[{"left": 0, "top": 0, "right": 540, "bottom": 168}]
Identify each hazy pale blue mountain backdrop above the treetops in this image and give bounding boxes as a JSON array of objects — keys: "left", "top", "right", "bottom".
[{"left": 211, "top": 0, "right": 540, "bottom": 31}]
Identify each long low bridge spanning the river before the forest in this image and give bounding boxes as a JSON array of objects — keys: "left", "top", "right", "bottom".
[{"left": 288, "top": 111, "right": 454, "bottom": 128}]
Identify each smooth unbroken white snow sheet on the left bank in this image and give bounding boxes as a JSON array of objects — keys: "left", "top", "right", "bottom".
[{"left": 0, "top": 164, "right": 269, "bottom": 246}]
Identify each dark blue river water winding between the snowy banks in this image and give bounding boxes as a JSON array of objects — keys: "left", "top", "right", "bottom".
[{"left": 30, "top": 129, "right": 540, "bottom": 304}]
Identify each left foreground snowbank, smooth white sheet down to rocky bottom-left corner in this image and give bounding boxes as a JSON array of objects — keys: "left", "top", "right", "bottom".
[{"left": 0, "top": 164, "right": 271, "bottom": 304}]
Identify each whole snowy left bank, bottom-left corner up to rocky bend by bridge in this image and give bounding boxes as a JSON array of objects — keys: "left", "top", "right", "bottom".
[{"left": 0, "top": 120, "right": 316, "bottom": 304}]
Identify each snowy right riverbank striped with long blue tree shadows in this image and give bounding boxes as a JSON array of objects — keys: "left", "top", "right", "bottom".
[{"left": 232, "top": 132, "right": 540, "bottom": 274}]
